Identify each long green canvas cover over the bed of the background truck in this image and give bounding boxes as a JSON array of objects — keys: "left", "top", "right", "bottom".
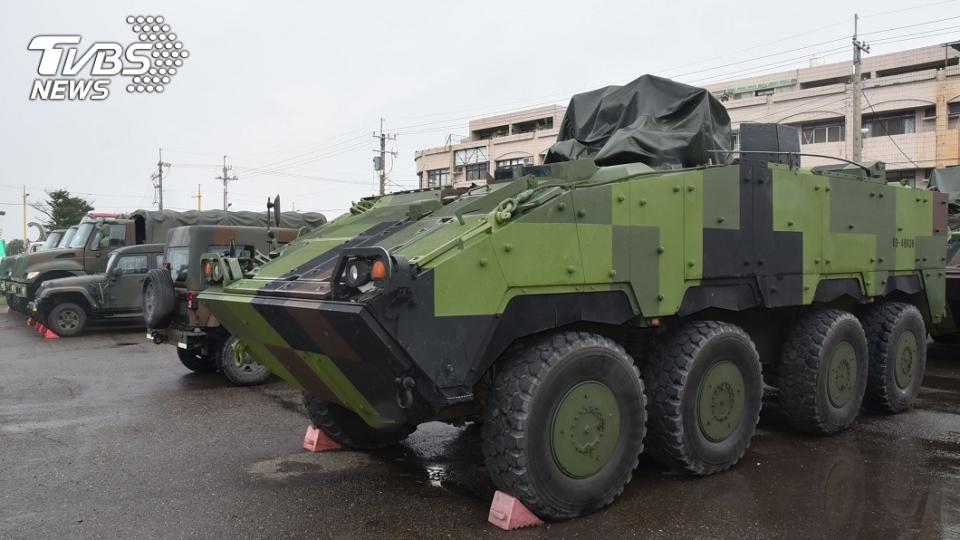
[{"left": 129, "top": 210, "right": 327, "bottom": 243}]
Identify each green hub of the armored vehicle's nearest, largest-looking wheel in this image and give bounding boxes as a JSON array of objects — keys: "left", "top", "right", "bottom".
[{"left": 550, "top": 381, "right": 620, "bottom": 478}]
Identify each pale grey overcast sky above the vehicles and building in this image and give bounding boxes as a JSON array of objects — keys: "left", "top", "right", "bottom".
[{"left": 0, "top": 0, "right": 960, "bottom": 239}]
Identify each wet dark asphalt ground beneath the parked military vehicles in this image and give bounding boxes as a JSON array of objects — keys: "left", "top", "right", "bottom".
[{"left": 0, "top": 307, "right": 960, "bottom": 538}]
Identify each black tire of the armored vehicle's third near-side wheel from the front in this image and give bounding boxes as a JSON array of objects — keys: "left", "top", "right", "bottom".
[{"left": 778, "top": 309, "right": 869, "bottom": 435}]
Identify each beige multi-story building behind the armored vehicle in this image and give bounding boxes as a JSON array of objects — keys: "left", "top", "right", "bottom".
[{"left": 416, "top": 43, "right": 960, "bottom": 187}]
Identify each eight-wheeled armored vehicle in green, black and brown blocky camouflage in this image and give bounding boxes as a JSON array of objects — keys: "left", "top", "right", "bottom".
[{"left": 201, "top": 76, "right": 947, "bottom": 519}]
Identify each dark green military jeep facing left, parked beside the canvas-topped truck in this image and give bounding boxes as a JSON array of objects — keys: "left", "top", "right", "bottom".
[{"left": 28, "top": 244, "right": 163, "bottom": 337}]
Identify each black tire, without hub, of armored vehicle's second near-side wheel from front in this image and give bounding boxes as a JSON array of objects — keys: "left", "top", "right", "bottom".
[{"left": 643, "top": 321, "right": 763, "bottom": 475}]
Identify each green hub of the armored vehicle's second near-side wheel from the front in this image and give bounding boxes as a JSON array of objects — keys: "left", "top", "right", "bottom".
[{"left": 697, "top": 360, "right": 745, "bottom": 442}]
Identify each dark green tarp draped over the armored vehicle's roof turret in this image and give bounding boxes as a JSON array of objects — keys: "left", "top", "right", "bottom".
[{"left": 545, "top": 75, "right": 732, "bottom": 167}]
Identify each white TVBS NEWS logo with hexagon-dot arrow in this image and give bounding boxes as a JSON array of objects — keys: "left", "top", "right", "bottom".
[{"left": 27, "top": 15, "right": 190, "bottom": 101}]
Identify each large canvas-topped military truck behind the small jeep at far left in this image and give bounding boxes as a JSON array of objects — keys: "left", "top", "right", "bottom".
[{"left": 0, "top": 210, "right": 326, "bottom": 312}]
